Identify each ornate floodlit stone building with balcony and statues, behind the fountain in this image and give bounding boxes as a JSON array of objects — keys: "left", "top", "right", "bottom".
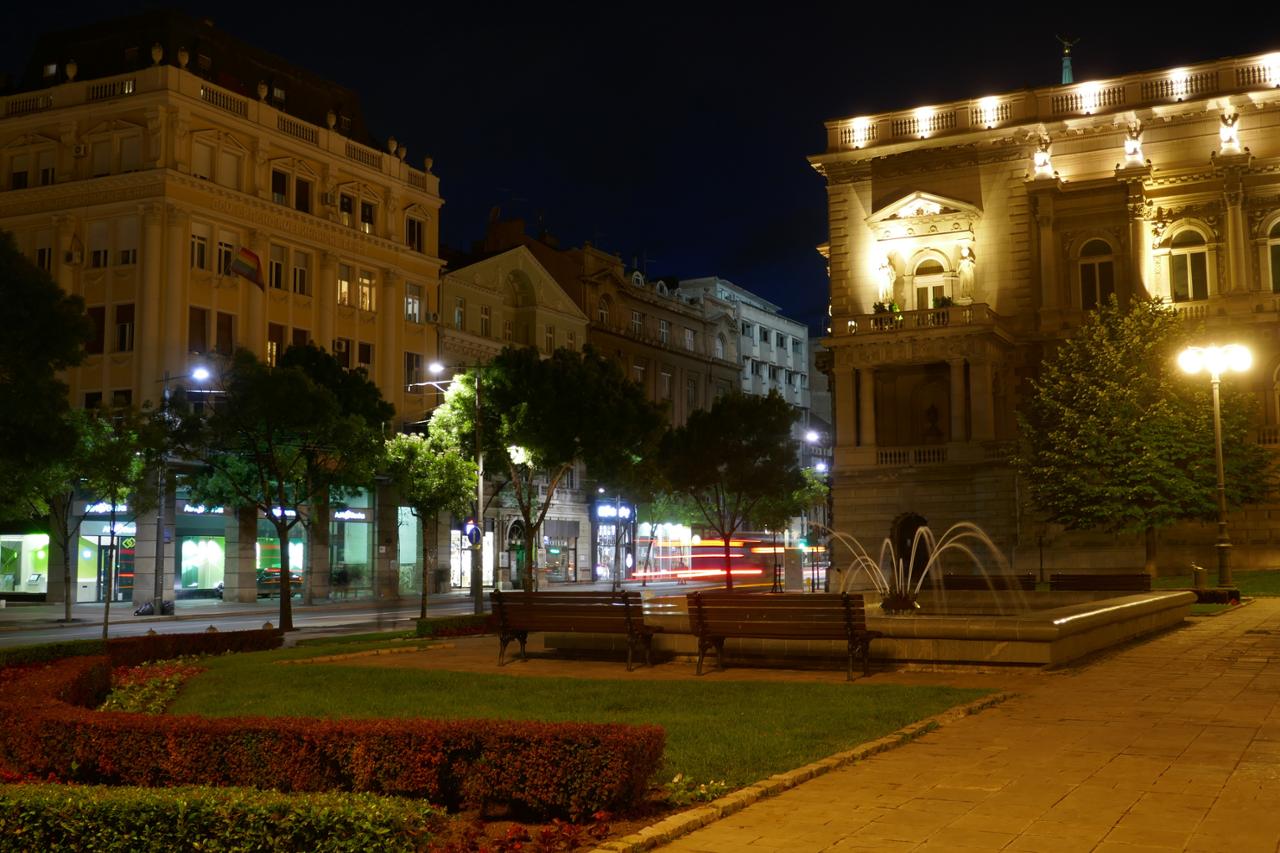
[{"left": 812, "top": 54, "right": 1280, "bottom": 571}]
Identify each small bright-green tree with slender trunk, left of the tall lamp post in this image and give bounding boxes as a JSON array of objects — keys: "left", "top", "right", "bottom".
[{"left": 387, "top": 433, "right": 476, "bottom": 619}]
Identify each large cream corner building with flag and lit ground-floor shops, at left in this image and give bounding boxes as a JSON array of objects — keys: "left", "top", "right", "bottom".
[{"left": 0, "top": 13, "right": 443, "bottom": 601}]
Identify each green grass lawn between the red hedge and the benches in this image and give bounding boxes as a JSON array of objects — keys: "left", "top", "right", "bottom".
[{"left": 169, "top": 643, "right": 988, "bottom": 788}]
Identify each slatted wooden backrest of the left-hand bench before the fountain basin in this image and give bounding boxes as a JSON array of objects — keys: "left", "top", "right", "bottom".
[{"left": 489, "top": 589, "right": 644, "bottom": 634}]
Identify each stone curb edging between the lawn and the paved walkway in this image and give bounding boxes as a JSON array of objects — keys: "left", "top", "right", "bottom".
[{"left": 590, "top": 693, "right": 1016, "bottom": 853}]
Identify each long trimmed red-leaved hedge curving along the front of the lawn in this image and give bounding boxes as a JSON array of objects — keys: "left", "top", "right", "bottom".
[{"left": 0, "top": 657, "right": 664, "bottom": 818}]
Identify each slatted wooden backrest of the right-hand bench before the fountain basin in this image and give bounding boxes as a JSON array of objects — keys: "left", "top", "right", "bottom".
[{"left": 687, "top": 592, "right": 867, "bottom": 639}]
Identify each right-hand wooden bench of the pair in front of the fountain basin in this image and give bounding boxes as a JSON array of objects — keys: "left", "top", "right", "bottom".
[{"left": 689, "top": 592, "right": 881, "bottom": 680}]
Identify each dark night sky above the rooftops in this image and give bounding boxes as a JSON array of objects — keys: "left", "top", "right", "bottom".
[{"left": 0, "top": 1, "right": 1280, "bottom": 330}]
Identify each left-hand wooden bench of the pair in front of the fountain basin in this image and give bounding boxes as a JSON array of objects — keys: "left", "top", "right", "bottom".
[{"left": 489, "top": 589, "right": 662, "bottom": 672}]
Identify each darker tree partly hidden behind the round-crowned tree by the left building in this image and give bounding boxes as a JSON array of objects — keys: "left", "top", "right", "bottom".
[{"left": 279, "top": 343, "right": 396, "bottom": 605}]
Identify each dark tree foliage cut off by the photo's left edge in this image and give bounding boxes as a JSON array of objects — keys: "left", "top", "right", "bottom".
[{"left": 0, "top": 232, "right": 92, "bottom": 510}]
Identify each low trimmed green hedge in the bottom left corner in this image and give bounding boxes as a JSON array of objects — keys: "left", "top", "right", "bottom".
[{"left": 0, "top": 785, "right": 443, "bottom": 853}]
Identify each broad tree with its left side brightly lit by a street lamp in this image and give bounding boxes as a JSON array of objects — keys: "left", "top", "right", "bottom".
[{"left": 429, "top": 346, "right": 663, "bottom": 589}]
